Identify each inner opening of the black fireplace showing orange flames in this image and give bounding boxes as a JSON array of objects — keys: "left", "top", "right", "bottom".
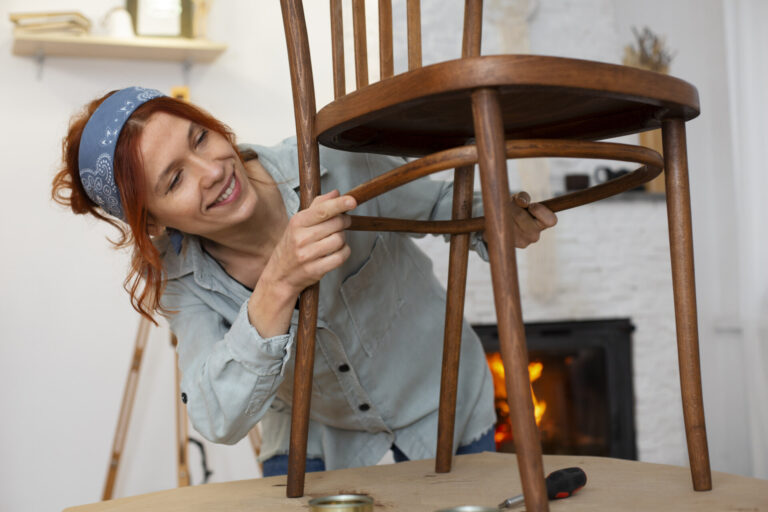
[{"left": 486, "top": 348, "right": 610, "bottom": 456}]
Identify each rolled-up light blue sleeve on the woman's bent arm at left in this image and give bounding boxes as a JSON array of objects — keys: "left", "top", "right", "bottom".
[{"left": 163, "top": 280, "right": 294, "bottom": 444}]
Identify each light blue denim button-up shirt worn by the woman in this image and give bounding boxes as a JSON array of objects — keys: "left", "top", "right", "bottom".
[{"left": 162, "top": 139, "right": 496, "bottom": 469}]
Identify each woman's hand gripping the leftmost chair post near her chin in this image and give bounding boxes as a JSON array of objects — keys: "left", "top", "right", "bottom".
[{"left": 262, "top": 190, "right": 357, "bottom": 297}]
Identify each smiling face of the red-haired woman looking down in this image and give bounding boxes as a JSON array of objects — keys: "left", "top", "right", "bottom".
[{"left": 139, "top": 112, "right": 258, "bottom": 239}]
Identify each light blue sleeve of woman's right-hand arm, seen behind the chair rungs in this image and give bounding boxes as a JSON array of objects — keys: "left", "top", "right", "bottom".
[{"left": 366, "top": 154, "right": 488, "bottom": 261}]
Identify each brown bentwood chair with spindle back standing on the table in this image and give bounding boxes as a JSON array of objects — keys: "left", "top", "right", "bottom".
[{"left": 281, "top": 0, "right": 711, "bottom": 511}]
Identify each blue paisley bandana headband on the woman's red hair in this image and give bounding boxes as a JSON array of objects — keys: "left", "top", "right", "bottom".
[{"left": 77, "top": 87, "right": 182, "bottom": 253}]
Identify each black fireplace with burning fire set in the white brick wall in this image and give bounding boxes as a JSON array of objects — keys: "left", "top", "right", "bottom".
[{"left": 473, "top": 319, "right": 637, "bottom": 459}]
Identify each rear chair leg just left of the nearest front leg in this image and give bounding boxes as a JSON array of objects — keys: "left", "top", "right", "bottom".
[{"left": 435, "top": 166, "right": 475, "bottom": 473}]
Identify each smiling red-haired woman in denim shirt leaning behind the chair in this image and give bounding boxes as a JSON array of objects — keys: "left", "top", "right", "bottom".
[{"left": 53, "top": 87, "right": 556, "bottom": 476}]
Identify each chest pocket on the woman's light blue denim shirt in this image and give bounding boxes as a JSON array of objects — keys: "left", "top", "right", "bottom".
[{"left": 341, "top": 235, "right": 405, "bottom": 357}]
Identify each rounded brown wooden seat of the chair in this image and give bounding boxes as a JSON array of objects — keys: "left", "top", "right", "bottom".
[{"left": 315, "top": 55, "right": 699, "bottom": 156}]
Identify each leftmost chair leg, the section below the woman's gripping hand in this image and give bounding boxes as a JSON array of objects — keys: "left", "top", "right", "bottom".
[{"left": 286, "top": 284, "right": 320, "bottom": 498}]
